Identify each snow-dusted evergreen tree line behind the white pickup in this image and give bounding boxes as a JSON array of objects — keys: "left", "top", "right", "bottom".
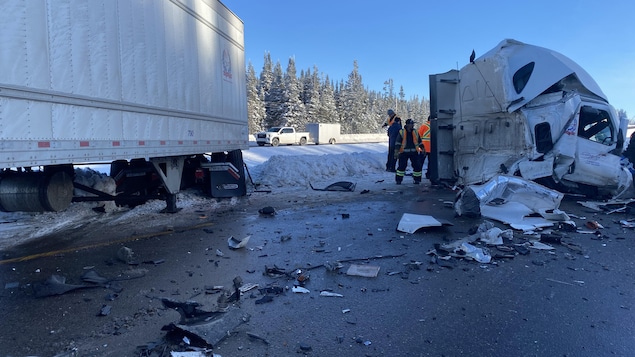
[{"left": 247, "top": 53, "right": 430, "bottom": 134}]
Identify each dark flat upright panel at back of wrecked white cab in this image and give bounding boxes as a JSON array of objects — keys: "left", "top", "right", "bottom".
[{"left": 428, "top": 69, "right": 459, "bottom": 182}]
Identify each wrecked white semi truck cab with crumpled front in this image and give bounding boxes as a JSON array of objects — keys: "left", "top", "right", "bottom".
[{"left": 429, "top": 40, "right": 632, "bottom": 196}]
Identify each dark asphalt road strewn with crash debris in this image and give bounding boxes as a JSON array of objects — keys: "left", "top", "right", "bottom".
[{"left": 0, "top": 174, "right": 635, "bottom": 356}]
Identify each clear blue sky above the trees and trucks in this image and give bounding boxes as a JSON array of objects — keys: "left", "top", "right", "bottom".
[{"left": 221, "top": 0, "right": 635, "bottom": 118}]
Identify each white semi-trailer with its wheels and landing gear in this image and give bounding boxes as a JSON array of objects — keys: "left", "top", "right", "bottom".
[{"left": 0, "top": 0, "right": 249, "bottom": 212}]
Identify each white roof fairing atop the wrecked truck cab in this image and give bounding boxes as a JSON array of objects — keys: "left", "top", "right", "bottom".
[{"left": 474, "top": 39, "right": 608, "bottom": 113}]
